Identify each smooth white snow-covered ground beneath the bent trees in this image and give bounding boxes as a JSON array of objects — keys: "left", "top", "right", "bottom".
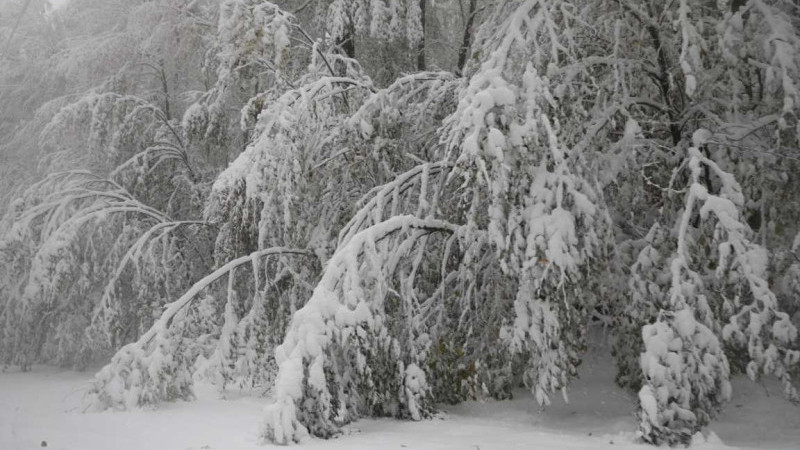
[{"left": 0, "top": 336, "right": 800, "bottom": 450}]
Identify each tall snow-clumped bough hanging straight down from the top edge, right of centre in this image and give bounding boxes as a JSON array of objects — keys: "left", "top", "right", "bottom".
[{"left": 443, "top": 0, "right": 612, "bottom": 412}]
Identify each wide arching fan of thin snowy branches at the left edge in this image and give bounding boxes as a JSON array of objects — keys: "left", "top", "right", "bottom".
[{"left": 0, "top": 167, "right": 195, "bottom": 368}]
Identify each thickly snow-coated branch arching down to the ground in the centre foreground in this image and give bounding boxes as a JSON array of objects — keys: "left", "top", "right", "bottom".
[{"left": 263, "top": 216, "right": 458, "bottom": 444}]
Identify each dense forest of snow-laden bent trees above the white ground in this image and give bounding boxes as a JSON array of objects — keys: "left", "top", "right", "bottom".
[{"left": 0, "top": 0, "right": 800, "bottom": 445}]
